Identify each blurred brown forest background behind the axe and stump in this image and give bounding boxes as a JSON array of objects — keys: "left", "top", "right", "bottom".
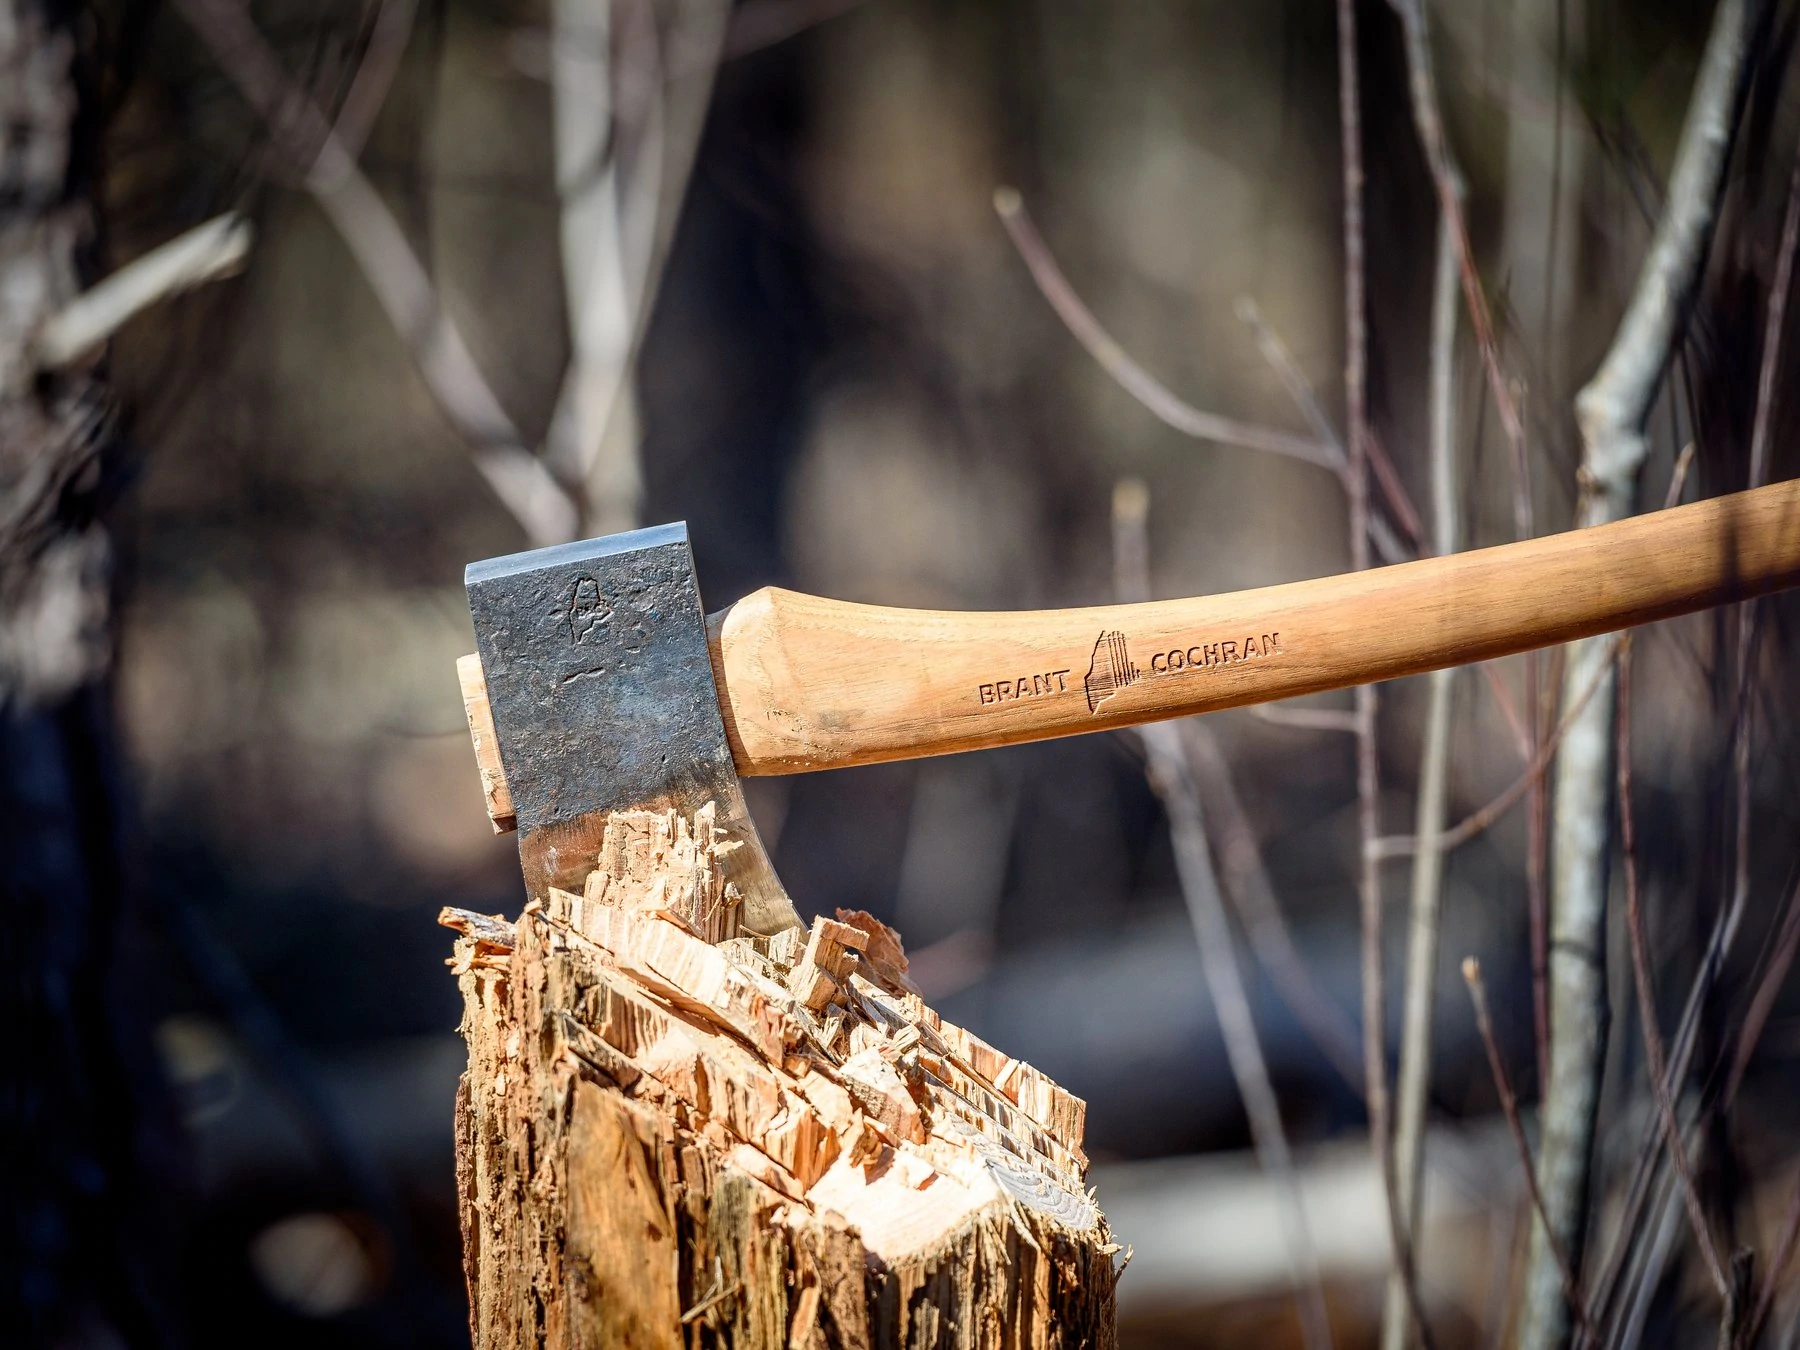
[{"left": 10, "top": 0, "right": 1800, "bottom": 1350}]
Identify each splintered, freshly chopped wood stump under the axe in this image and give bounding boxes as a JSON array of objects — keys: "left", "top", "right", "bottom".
[{"left": 443, "top": 810, "right": 1121, "bottom": 1350}]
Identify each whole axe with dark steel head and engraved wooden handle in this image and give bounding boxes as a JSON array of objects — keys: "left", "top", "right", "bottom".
[{"left": 457, "top": 481, "right": 1800, "bottom": 932}]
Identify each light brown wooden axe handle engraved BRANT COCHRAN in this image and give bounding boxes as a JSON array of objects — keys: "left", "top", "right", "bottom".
[{"left": 464, "top": 481, "right": 1800, "bottom": 806}]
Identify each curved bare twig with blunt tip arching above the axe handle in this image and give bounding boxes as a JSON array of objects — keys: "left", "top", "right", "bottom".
[{"left": 994, "top": 187, "right": 1339, "bottom": 472}]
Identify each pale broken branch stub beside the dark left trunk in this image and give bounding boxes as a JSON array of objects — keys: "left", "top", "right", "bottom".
[{"left": 31, "top": 211, "right": 252, "bottom": 371}]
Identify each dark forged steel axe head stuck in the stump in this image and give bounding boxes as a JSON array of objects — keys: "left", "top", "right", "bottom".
[{"left": 464, "top": 524, "right": 799, "bottom": 932}]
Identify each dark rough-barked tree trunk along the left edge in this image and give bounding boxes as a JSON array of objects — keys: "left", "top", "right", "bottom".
[{"left": 0, "top": 0, "right": 180, "bottom": 1346}]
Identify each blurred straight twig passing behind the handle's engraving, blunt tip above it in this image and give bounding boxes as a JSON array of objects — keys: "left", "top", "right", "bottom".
[{"left": 1112, "top": 481, "right": 1332, "bottom": 1350}]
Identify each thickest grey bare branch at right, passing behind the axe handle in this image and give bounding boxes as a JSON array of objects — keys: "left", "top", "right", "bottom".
[{"left": 1519, "top": 0, "right": 1764, "bottom": 1350}]
